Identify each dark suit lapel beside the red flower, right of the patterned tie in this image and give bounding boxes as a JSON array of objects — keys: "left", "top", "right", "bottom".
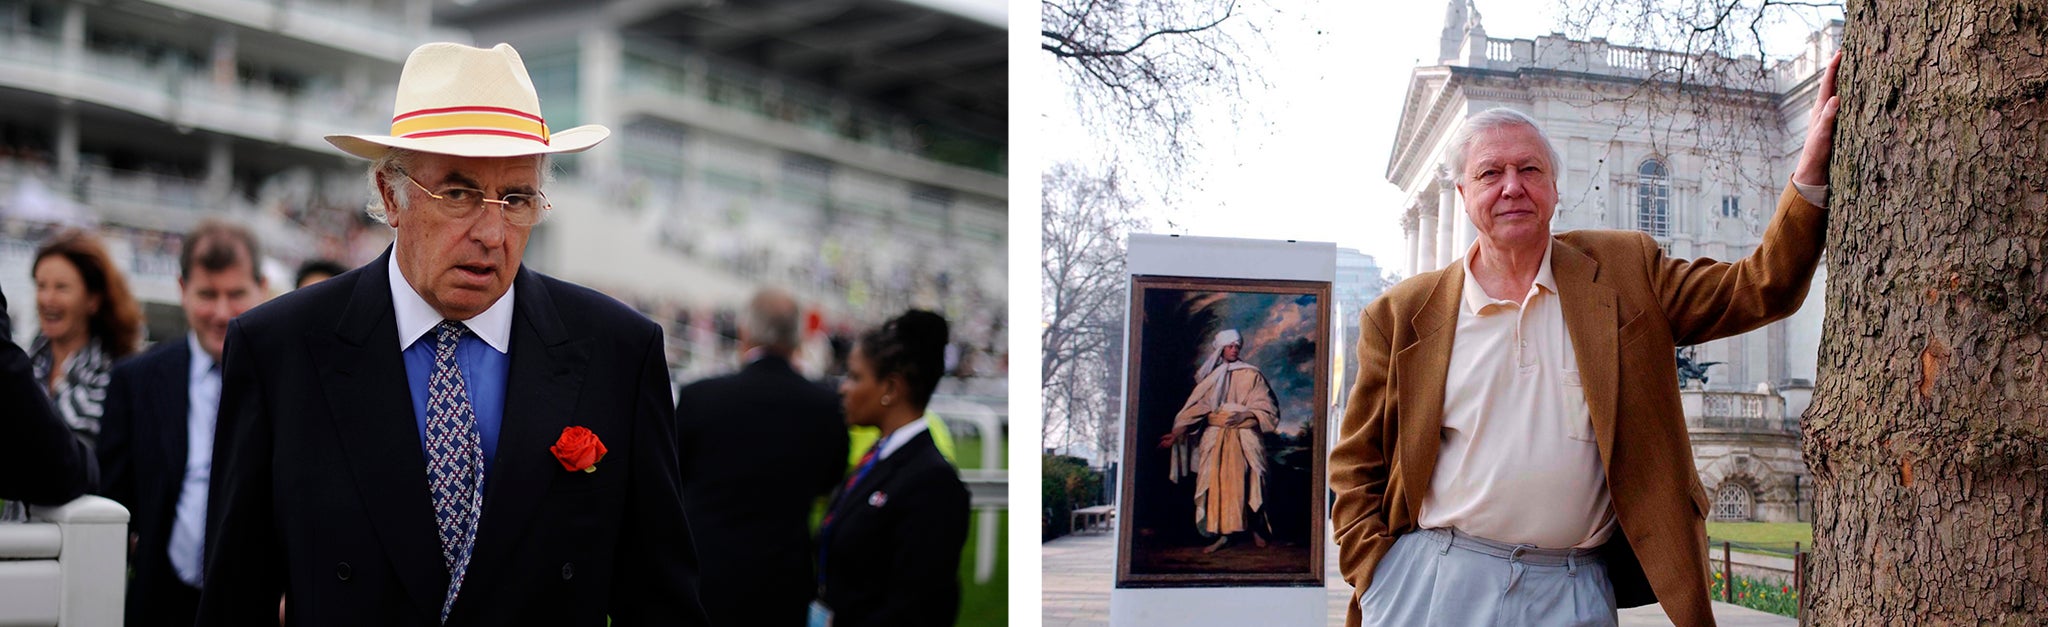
[{"left": 457, "top": 268, "right": 589, "bottom": 609}]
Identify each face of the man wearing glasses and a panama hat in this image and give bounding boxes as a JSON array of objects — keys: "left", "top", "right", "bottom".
[{"left": 381, "top": 154, "right": 541, "bottom": 320}]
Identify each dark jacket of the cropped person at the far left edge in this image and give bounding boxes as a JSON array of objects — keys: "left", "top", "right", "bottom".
[{"left": 0, "top": 286, "right": 100, "bottom": 504}]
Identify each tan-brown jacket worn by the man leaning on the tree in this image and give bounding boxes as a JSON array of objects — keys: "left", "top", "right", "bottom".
[{"left": 1329, "top": 186, "right": 1827, "bottom": 627}]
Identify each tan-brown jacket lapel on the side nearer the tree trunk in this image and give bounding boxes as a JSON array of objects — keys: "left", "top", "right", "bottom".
[{"left": 1550, "top": 240, "right": 1620, "bottom": 473}]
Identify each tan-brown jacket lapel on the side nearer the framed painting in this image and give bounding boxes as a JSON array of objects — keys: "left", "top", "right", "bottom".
[{"left": 1395, "top": 264, "right": 1464, "bottom": 516}]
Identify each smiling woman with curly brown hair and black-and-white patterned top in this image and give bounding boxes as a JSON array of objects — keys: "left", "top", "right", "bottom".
[{"left": 29, "top": 229, "right": 141, "bottom": 447}]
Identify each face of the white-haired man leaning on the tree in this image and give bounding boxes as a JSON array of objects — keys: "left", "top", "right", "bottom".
[{"left": 1458, "top": 125, "right": 1556, "bottom": 246}]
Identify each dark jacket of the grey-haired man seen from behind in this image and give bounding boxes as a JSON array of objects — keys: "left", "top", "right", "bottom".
[{"left": 676, "top": 354, "right": 846, "bottom": 627}]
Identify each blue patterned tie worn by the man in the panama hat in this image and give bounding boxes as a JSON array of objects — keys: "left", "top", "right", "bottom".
[{"left": 426, "top": 320, "right": 483, "bottom": 623}]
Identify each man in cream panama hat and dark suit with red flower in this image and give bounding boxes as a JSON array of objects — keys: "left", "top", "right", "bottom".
[{"left": 199, "top": 43, "right": 705, "bottom": 625}]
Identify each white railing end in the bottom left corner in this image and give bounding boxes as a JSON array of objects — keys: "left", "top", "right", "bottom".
[{"left": 0, "top": 496, "right": 129, "bottom": 625}]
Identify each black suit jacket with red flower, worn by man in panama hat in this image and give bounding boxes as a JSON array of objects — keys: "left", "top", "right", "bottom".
[{"left": 199, "top": 252, "right": 705, "bottom": 627}]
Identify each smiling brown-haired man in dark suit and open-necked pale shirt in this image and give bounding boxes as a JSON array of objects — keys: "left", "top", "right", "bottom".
[{"left": 98, "top": 219, "right": 264, "bottom": 627}]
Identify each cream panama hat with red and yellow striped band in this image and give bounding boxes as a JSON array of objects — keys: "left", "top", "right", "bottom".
[{"left": 328, "top": 43, "right": 612, "bottom": 160}]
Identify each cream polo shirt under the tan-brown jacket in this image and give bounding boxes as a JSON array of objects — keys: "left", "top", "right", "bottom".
[{"left": 1417, "top": 244, "right": 1614, "bottom": 549}]
